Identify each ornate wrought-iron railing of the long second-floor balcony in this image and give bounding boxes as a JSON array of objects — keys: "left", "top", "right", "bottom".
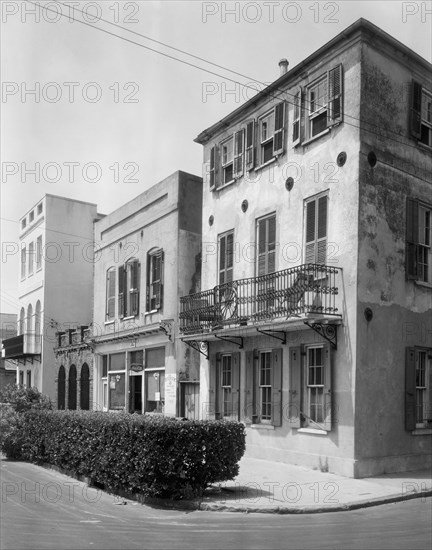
[{"left": 180, "top": 264, "right": 342, "bottom": 334}]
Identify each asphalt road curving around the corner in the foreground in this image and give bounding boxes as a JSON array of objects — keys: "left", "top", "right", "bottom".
[{"left": 1, "top": 461, "right": 432, "bottom": 550}]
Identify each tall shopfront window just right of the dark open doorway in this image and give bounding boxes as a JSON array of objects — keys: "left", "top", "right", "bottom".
[{"left": 144, "top": 348, "right": 165, "bottom": 413}]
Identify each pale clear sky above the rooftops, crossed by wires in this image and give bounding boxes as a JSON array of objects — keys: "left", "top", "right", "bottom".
[{"left": 0, "top": 0, "right": 432, "bottom": 312}]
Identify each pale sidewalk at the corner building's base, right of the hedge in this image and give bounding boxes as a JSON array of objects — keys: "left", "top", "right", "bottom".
[{"left": 190, "top": 458, "right": 432, "bottom": 514}]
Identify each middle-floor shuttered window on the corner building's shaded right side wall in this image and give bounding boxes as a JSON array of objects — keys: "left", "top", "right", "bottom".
[{"left": 405, "top": 198, "right": 432, "bottom": 283}]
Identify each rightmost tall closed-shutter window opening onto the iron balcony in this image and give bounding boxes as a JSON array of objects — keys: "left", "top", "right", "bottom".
[{"left": 305, "top": 195, "right": 328, "bottom": 264}]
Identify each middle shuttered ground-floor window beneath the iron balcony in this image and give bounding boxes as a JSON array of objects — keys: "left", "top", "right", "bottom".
[{"left": 245, "top": 349, "right": 282, "bottom": 426}]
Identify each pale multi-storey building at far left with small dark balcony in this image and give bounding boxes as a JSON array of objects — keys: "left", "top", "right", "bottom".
[{"left": 3, "top": 195, "right": 99, "bottom": 400}]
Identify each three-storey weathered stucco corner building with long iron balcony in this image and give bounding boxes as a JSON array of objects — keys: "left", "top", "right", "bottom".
[{"left": 180, "top": 20, "right": 432, "bottom": 477}]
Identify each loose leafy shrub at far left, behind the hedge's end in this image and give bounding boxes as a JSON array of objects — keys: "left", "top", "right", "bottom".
[{"left": 0, "top": 384, "right": 52, "bottom": 459}]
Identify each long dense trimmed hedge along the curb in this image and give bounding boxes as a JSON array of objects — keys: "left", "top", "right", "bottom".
[{"left": 5, "top": 410, "right": 245, "bottom": 499}]
